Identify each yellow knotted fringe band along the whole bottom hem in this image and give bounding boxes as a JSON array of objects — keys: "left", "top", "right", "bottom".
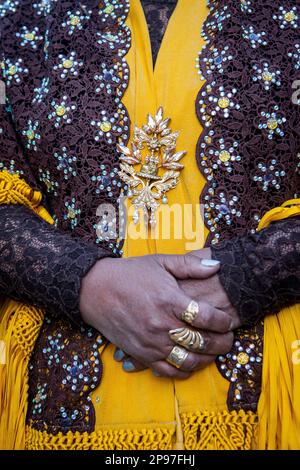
[{"left": 26, "top": 411, "right": 258, "bottom": 450}]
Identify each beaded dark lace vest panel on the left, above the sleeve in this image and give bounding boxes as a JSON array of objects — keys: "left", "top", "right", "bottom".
[{"left": 0, "top": 0, "right": 131, "bottom": 254}]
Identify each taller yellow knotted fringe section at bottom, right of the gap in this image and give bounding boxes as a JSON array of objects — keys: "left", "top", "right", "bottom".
[{"left": 181, "top": 411, "right": 258, "bottom": 450}]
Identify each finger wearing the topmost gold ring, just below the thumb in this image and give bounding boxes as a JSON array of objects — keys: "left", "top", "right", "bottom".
[{"left": 171, "top": 296, "right": 232, "bottom": 333}]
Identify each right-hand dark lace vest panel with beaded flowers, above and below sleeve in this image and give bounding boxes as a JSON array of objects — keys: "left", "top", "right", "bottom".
[{"left": 196, "top": 0, "right": 300, "bottom": 410}]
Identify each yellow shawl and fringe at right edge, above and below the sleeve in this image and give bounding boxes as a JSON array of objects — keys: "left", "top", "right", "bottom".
[{"left": 258, "top": 199, "right": 300, "bottom": 450}]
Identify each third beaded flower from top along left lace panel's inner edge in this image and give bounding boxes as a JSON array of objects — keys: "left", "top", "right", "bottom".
[{"left": 94, "top": 59, "right": 129, "bottom": 95}]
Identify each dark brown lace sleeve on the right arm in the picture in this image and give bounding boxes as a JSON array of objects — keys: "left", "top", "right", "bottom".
[{"left": 212, "top": 217, "right": 300, "bottom": 326}]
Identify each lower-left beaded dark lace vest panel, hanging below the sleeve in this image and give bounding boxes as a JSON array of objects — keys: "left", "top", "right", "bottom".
[{"left": 27, "top": 315, "right": 105, "bottom": 435}]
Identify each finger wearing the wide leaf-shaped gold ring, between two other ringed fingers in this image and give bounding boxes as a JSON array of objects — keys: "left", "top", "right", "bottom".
[{"left": 169, "top": 328, "right": 234, "bottom": 355}]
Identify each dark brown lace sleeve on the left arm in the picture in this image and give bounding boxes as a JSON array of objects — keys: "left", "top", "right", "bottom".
[{"left": 0, "top": 205, "right": 112, "bottom": 323}]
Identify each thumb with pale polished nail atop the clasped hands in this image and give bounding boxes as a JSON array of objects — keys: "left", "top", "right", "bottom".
[{"left": 159, "top": 253, "right": 220, "bottom": 279}]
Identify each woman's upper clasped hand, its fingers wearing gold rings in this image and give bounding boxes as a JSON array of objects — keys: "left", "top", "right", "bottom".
[{"left": 80, "top": 253, "right": 233, "bottom": 378}]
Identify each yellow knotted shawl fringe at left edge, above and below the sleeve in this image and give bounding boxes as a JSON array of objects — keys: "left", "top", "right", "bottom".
[{"left": 0, "top": 171, "right": 53, "bottom": 450}]
